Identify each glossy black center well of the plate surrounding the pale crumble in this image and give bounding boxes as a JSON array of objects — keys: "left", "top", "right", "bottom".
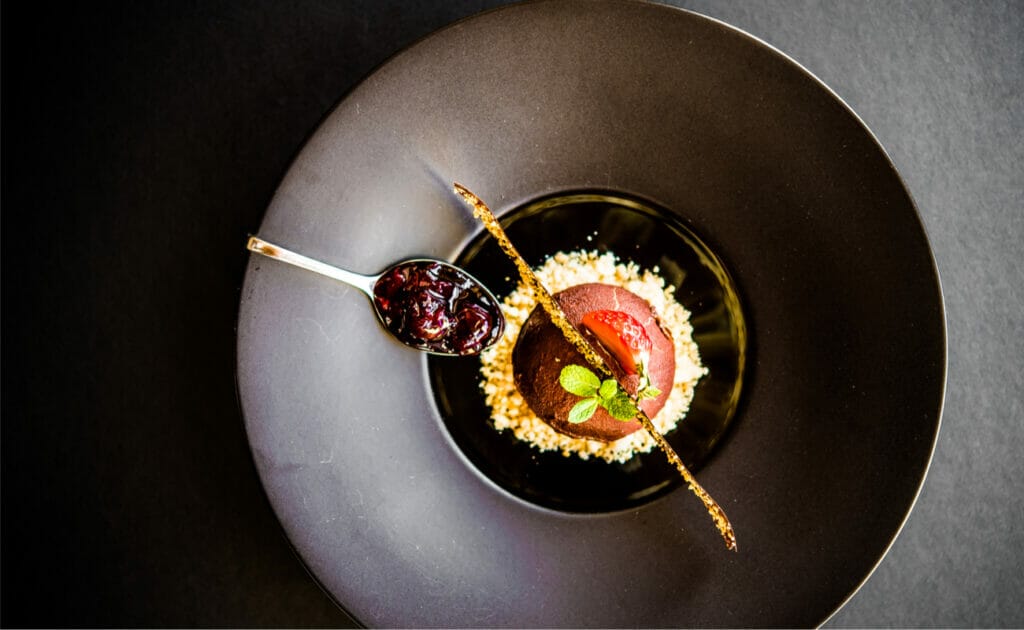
[{"left": 428, "top": 193, "right": 746, "bottom": 512}]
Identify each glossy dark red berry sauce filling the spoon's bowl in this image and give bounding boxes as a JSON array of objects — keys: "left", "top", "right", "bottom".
[{"left": 374, "top": 260, "right": 505, "bottom": 354}]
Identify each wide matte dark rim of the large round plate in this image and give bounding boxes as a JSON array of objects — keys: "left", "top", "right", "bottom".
[{"left": 239, "top": 0, "right": 945, "bottom": 627}]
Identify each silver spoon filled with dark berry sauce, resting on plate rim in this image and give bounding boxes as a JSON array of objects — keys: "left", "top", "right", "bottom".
[{"left": 247, "top": 237, "right": 505, "bottom": 356}]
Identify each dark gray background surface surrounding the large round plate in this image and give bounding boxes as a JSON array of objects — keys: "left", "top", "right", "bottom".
[{"left": 0, "top": 1, "right": 1024, "bottom": 627}]
